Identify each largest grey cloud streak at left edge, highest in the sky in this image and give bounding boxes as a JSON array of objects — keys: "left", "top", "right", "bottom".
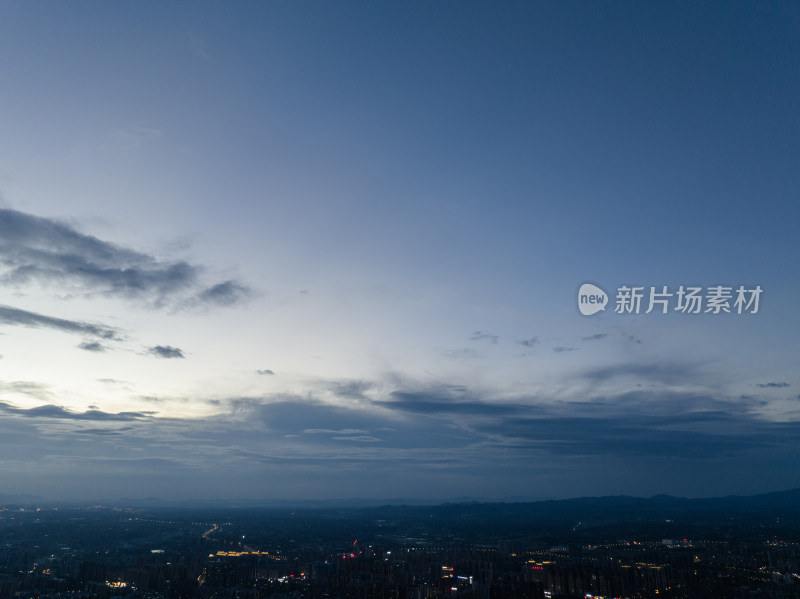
[{"left": 0, "top": 209, "right": 249, "bottom": 307}]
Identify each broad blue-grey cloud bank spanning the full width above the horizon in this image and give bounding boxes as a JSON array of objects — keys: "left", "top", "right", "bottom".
[{"left": 0, "top": 379, "right": 800, "bottom": 496}]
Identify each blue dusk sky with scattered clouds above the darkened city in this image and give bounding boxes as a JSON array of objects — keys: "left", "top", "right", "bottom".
[{"left": 0, "top": 0, "right": 800, "bottom": 501}]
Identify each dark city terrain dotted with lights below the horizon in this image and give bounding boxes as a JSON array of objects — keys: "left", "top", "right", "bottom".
[{"left": 0, "top": 490, "right": 800, "bottom": 599}]
